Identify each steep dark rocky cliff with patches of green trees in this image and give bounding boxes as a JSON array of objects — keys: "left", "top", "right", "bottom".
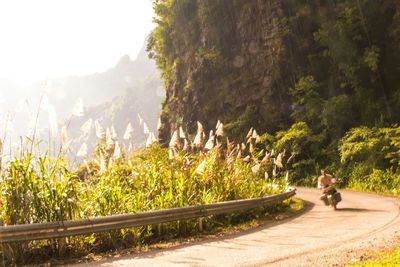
[{"left": 148, "top": 0, "right": 400, "bottom": 146}]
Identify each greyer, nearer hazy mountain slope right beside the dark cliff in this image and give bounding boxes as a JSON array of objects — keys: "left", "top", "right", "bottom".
[{"left": 68, "top": 45, "right": 165, "bottom": 155}]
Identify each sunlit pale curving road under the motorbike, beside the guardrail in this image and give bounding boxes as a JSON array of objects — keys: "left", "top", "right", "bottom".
[{"left": 79, "top": 189, "right": 400, "bottom": 266}]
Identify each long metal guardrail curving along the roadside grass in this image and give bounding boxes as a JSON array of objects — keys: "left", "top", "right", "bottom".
[{"left": 0, "top": 189, "right": 296, "bottom": 243}]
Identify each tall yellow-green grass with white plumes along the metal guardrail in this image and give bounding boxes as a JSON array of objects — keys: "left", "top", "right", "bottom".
[{"left": 0, "top": 122, "right": 294, "bottom": 263}]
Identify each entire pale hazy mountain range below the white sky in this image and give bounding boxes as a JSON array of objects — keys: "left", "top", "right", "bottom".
[{"left": 0, "top": 41, "right": 165, "bottom": 155}]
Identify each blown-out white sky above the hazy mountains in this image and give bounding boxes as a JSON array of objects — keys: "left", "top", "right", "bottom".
[{"left": 0, "top": 0, "right": 153, "bottom": 83}]
